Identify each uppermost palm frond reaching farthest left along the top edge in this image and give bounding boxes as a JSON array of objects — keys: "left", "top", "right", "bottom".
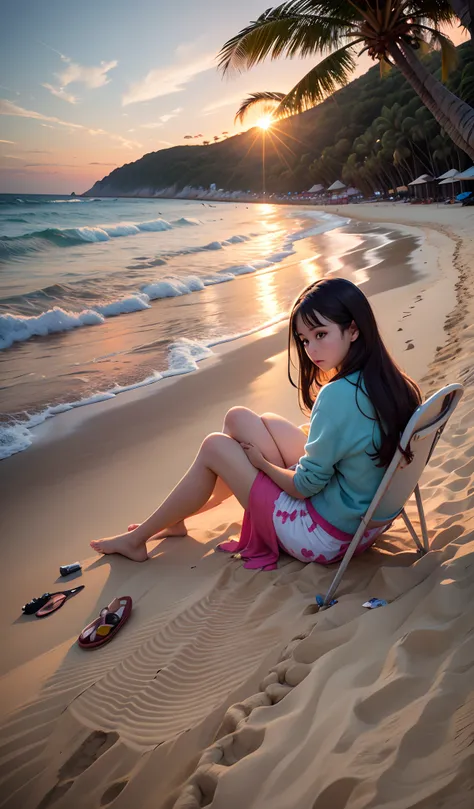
[{"left": 217, "top": 2, "right": 354, "bottom": 73}]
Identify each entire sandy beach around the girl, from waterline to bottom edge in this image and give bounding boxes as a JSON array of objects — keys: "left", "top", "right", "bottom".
[{"left": 0, "top": 204, "right": 474, "bottom": 809}]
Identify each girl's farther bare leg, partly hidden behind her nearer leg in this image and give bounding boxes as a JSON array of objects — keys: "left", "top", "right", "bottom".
[{"left": 131, "top": 407, "right": 306, "bottom": 539}]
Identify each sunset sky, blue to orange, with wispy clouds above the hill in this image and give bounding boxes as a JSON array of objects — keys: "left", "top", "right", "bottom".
[{"left": 0, "top": 0, "right": 465, "bottom": 194}]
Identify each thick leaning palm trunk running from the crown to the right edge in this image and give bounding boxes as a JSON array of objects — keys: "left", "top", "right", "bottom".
[{"left": 390, "top": 45, "right": 474, "bottom": 162}]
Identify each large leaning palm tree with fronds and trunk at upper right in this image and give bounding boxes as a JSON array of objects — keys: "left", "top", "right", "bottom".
[{"left": 219, "top": 0, "right": 474, "bottom": 160}]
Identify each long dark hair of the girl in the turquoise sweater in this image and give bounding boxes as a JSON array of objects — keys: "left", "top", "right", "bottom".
[{"left": 288, "top": 278, "right": 422, "bottom": 467}]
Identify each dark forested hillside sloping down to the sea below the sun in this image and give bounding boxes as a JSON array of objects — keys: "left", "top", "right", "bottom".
[{"left": 86, "top": 42, "right": 474, "bottom": 196}]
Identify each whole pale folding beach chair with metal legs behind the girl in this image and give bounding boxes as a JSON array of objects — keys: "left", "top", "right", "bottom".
[{"left": 322, "top": 383, "right": 464, "bottom": 609}]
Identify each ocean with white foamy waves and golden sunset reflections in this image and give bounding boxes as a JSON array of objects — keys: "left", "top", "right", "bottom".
[{"left": 0, "top": 195, "right": 413, "bottom": 459}]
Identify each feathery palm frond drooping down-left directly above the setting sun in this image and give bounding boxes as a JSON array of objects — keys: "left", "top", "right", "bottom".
[{"left": 275, "top": 40, "right": 361, "bottom": 118}]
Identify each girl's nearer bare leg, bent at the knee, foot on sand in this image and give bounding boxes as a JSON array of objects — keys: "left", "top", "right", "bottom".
[{"left": 91, "top": 433, "right": 257, "bottom": 562}]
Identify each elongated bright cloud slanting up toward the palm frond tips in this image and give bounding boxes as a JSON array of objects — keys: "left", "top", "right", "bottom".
[{"left": 122, "top": 49, "right": 215, "bottom": 107}]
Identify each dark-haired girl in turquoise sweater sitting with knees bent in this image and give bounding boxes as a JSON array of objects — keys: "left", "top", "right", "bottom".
[{"left": 91, "top": 278, "right": 421, "bottom": 570}]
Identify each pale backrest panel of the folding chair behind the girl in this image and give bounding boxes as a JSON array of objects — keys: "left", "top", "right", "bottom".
[{"left": 364, "top": 383, "right": 464, "bottom": 527}]
